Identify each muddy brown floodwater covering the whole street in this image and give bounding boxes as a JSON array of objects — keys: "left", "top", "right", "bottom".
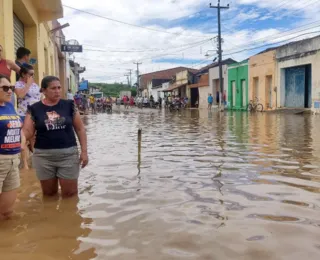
[{"left": 0, "top": 111, "right": 320, "bottom": 260}]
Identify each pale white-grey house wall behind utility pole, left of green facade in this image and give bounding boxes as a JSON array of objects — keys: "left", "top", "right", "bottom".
[{"left": 209, "top": 65, "right": 229, "bottom": 102}]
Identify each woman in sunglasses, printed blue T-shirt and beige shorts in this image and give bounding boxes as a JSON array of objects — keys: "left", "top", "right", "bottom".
[{"left": 0, "top": 74, "right": 22, "bottom": 220}]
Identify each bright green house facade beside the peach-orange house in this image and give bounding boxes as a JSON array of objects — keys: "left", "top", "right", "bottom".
[{"left": 228, "top": 60, "right": 249, "bottom": 110}]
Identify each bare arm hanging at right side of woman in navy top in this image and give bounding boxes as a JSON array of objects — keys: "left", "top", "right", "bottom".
[{"left": 73, "top": 111, "right": 89, "bottom": 168}]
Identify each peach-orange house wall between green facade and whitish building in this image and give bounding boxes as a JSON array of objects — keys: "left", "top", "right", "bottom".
[{"left": 249, "top": 50, "right": 276, "bottom": 110}]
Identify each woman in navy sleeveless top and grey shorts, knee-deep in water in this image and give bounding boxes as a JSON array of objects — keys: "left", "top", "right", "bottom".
[{"left": 23, "top": 76, "right": 88, "bottom": 197}]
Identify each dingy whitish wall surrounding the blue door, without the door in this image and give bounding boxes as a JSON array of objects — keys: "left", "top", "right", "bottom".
[{"left": 276, "top": 51, "right": 320, "bottom": 112}]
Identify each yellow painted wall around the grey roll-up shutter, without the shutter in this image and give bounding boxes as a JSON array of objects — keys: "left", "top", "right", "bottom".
[{"left": 0, "top": 0, "right": 58, "bottom": 84}]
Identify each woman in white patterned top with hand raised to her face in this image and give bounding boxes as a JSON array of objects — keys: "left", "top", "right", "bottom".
[{"left": 15, "top": 64, "right": 41, "bottom": 170}]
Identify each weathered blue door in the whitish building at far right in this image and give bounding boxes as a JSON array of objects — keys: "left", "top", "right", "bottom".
[{"left": 285, "top": 66, "right": 308, "bottom": 108}]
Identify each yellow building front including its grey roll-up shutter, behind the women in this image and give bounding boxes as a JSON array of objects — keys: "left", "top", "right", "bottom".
[{"left": 0, "top": 0, "right": 63, "bottom": 84}]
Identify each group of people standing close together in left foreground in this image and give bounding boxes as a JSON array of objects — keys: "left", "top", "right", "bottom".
[{"left": 0, "top": 45, "right": 88, "bottom": 220}]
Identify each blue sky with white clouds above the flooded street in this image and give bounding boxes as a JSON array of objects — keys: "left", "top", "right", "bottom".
[{"left": 60, "top": 0, "right": 320, "bottom": 82}]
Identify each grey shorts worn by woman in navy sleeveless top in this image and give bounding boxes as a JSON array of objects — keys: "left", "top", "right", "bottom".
[{"left": 32, "top": 147, "right": 80, "bottom": 181}]
